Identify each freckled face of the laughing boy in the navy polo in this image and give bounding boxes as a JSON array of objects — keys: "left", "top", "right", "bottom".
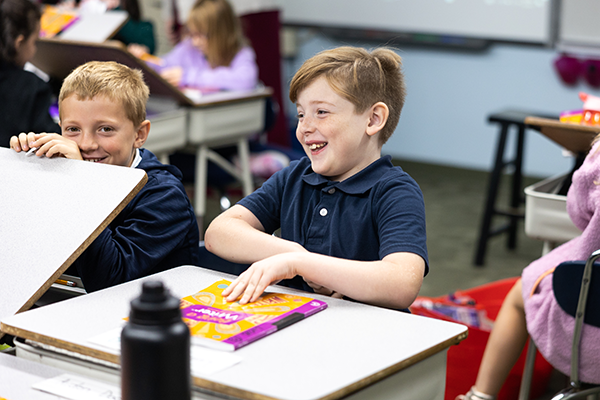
[{"left": 296, "top": 77, "right": 380, "bottom": 181}]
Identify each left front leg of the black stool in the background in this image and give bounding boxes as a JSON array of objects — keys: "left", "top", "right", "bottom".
[{"left": 475, "top": 124, "right": 508, "bottom": 266}]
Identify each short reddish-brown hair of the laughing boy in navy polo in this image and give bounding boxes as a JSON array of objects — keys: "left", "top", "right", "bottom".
[{"left": 290, "top": 46, "right": 406, "bottom": 145}]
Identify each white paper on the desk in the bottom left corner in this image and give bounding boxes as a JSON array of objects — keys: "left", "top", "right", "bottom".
[{"left": 32, "top": 374, "right": 121, "bottom": 400}]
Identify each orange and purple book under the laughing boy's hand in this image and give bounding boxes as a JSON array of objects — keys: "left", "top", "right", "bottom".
[{"left": 181, "top": 279, "right": 327, "bottom": 351}]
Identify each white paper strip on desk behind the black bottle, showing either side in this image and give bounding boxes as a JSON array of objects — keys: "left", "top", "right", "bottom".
[{"left": 88, "top": 327, "right": 242, "bottom": 376}]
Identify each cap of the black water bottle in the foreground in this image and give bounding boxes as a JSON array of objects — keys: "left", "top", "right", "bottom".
[{"left": 129, "top": 281, "right": 181, "bottom": 325}]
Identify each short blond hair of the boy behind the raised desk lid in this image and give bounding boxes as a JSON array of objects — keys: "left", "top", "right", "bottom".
[{"left": 58, "top": 61, "right": 150, "bottom": 126}]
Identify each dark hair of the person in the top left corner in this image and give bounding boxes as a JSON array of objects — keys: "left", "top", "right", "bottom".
[{"left": 0, "top": 0, "right": 41, "bottom": 64}]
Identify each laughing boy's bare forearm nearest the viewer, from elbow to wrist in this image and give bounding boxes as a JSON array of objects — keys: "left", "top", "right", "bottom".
[{"left": 290, "top": 253, "right": 425, "bottom": 309}]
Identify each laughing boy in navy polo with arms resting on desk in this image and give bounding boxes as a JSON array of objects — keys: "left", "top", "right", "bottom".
[{"left": 205, "top": 47, "right": 428, "bottom": 309}]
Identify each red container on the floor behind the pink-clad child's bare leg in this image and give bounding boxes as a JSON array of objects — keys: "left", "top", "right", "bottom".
[{"left": 410, "top": 278, "right": 553, "bottom": 400}]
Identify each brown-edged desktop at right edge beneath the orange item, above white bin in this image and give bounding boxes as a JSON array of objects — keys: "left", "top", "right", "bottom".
[{"left": 525, "top": 117, "right": 600, "bottom": 154}]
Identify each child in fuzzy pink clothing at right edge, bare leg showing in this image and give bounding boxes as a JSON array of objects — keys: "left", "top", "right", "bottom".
[{"left": 457, "top": 135, "right": 600, "bottom": 400}]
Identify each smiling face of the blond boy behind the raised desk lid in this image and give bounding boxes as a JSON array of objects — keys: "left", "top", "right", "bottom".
[{"left": 60, "top": 95, "right": 149, "bottom": 167}]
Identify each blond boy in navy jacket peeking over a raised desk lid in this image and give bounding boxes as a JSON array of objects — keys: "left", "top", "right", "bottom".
[{"left": 10, "top": 62, "right": 199, "bottom": 292}]
